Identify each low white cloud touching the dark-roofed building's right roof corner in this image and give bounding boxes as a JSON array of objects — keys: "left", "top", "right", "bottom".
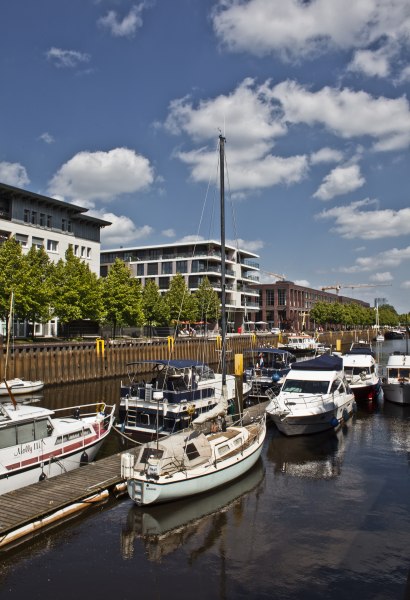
[{"left": 93, "top": 210, "right": 154, "bottom": 247}]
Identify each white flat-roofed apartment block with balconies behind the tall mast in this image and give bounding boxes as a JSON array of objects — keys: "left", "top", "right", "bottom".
[{"left": 101, "top": 240, "right": 259, "bottom": 331}]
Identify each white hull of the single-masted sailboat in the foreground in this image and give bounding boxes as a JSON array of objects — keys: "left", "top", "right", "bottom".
[{"left": 127, "top": 423, "right": 266, "bottom": 506}]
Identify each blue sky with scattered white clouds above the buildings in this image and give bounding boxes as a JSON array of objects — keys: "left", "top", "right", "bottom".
[{"left": 0, "top": 0, "right": 410, "bottom": 313}]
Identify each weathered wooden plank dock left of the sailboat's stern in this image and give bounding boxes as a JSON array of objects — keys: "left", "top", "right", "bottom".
[{"left": 0, "top": 450, "right": 136, "bottom": 548}]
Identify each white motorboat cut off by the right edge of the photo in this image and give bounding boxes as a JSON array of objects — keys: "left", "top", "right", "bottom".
[{"left": 382, "top": 352, "right": 410, "bottom": 404}]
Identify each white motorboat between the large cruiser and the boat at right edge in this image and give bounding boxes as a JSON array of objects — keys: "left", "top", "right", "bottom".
[{"left": 342, "top": 341, "right": 382, "bottom": 400}]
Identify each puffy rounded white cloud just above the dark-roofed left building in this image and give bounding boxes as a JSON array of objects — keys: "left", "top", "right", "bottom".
[{"left": 49, "top": 148, "right": 154, "bottom": 206}]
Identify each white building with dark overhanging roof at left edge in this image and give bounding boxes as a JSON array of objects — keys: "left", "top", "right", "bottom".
[{"left": 0, "top": 183, "right": 111, "bottom": 336}]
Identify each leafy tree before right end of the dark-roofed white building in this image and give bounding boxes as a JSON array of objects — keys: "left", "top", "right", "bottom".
[{"left": 52, "top": 248, "right": 103, "bottom": 323}]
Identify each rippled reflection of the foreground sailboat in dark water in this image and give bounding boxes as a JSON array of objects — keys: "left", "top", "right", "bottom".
[{"left": 121, "top": 460, "right": 265, "bottom": 562}]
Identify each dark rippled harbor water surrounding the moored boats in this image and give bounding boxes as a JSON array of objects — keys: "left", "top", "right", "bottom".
[{"left": 0, "top": 340, "right": 410, "bottom": 600}]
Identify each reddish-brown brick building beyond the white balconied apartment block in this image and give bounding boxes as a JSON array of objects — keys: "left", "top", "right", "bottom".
[{"left": 254, "top": 281, "right": 370, "bottom": 331}]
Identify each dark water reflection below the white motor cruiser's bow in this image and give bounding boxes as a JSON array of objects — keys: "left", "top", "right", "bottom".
[{"left": 267, "top": 424, "right": 350, "bottom": 479}]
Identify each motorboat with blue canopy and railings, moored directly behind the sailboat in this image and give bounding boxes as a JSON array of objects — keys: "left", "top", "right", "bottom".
[{"left": 116, "top": 359, "right": 251, "bottom": 437}]
